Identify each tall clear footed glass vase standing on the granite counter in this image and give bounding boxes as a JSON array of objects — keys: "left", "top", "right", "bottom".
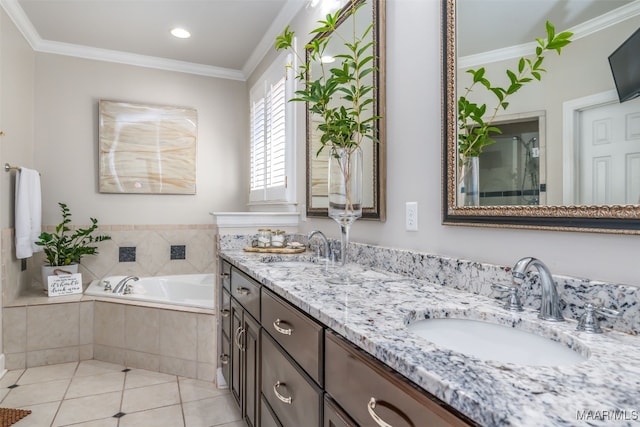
[{"left": 329, "top": 147, "right": 362, "bottom": 283}]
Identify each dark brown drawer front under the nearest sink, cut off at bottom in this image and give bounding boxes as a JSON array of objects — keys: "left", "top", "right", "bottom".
[{"left": 325, "top": 333, "right": 472, "bottom": 427}]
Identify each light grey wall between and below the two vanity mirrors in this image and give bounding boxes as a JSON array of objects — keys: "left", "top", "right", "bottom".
[{"left": 286, "top": 0, "right": 640, "bottom": 285}]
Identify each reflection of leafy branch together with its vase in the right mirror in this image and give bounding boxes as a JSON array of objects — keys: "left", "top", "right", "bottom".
[{"left": 458, "top": 21, "right": 573, "bottom": 206}]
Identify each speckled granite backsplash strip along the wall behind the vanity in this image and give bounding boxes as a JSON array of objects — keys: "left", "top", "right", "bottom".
[{"left": 216, "top": 234, "right": 640, "bottom": 335}]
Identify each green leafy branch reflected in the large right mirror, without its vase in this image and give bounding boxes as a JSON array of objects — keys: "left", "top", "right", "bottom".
[{"left": 458, "top": 21, "right": 573, "bottom": 159}]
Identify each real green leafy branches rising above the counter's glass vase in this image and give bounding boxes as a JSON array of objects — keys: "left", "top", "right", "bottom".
[{"left": 275, "top": 0, "right": 380, "bottom": 154}]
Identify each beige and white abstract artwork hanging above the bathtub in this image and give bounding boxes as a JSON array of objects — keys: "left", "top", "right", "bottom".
[{"left": 98, "top": 100, "right": 198, "bottom": 194}]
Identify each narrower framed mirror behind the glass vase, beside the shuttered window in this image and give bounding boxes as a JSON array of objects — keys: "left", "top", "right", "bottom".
[{"left": 306, "top": 0, "right": 386, "bottom": 221}]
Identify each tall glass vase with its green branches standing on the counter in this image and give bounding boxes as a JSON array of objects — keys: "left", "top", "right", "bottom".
[{"left": 275, "top": 0, "right": 380, "bottom": 274}]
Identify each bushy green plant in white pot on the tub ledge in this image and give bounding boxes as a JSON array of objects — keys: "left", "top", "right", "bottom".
[{"left": 35, "top": 202, "right": 111, "bottom": 289}]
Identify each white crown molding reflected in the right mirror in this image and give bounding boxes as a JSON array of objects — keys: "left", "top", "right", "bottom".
[{"left": 457, "top": 0, "right": 640, "bottom": 68}]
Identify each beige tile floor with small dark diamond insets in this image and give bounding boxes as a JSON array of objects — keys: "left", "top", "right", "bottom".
[{"left": 0, "top": 360, "right": 245, "bottom": 427}]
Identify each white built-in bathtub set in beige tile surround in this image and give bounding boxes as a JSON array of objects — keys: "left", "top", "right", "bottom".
[{"left": 84, "top": 274, "right": 215, "bottom": 310}]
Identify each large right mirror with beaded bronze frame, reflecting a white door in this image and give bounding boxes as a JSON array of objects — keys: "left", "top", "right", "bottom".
[{"left": 442, "top": 0, "right": 640, "bottom": 234}]
